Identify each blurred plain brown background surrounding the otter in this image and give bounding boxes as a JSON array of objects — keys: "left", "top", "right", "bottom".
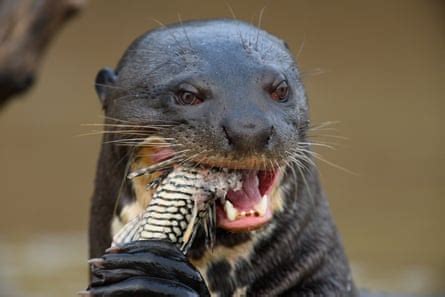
[{"left": 0, "top": 0, "right": 445, "bottom": 297}]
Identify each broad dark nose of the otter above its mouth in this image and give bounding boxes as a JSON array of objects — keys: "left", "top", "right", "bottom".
[{"left": 222, "top": 119, "right": 273, "bottom": 153}]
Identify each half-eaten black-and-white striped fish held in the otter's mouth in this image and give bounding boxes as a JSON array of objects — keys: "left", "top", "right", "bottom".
[{"left": 113, "top": 164, "right": 241, "bottom": 254}]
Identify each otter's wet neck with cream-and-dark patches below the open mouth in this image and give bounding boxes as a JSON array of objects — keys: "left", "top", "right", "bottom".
[{"left": 190, "top": 167, "right": 356, "bottom": 296}]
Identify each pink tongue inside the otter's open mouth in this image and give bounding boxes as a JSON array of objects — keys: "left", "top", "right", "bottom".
[{"left": 226, "top": 170, "right": 261, "bottom": 210}]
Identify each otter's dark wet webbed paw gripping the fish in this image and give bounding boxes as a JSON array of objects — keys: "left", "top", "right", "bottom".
[{"left": 84, "top": 240, "right": 210, "bottom": 297}]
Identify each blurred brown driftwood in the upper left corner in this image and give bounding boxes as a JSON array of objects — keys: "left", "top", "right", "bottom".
[{"left": 0, "top": 0, "right": 86, "bottom": 108}]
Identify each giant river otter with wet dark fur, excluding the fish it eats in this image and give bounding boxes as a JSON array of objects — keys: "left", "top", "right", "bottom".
[{"left": 84, "top": 20, "right": 358, "bottom": 297}]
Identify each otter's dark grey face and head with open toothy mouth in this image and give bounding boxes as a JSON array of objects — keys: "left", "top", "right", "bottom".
[{"left": 96, "top": 21, "right": 308, "bottom": 232}]
